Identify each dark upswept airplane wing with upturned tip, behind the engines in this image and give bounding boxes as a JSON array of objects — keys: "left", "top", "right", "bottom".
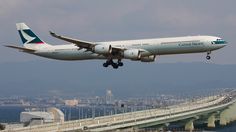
[{"left": 50, "top": 31, "right": 96, "bottom": 50}]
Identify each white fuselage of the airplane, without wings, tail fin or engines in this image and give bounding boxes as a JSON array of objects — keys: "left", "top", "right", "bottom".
[{"left": 33, "top": 36, "right": 226, "bottom": 60}]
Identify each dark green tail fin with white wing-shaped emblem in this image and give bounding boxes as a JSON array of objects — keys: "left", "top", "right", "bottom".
[{"left": 16, "top": 23, "right": 45, "bottom": 46}]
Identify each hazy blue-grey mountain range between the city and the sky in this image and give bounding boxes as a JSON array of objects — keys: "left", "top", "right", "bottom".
[{"left": 0, "top": 61, "right": 236, "bottom": 98}]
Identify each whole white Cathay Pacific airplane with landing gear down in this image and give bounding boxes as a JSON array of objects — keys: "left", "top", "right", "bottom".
[{"left": 5, "top": 23, "right": 227, "bottom": 69}]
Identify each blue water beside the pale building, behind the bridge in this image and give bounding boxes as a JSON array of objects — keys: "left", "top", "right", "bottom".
[{"left": 0, "top": 106, "right": 131, "bottom": 123}]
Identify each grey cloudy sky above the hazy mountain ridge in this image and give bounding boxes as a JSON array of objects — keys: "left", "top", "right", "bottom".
[{"left": 0, "top": 0, "right": 236, "bottom": 64}]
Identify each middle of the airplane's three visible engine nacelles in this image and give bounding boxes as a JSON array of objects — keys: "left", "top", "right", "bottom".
[{"left": 124, "top": 49, "right": 141, "bottom": 60}]
